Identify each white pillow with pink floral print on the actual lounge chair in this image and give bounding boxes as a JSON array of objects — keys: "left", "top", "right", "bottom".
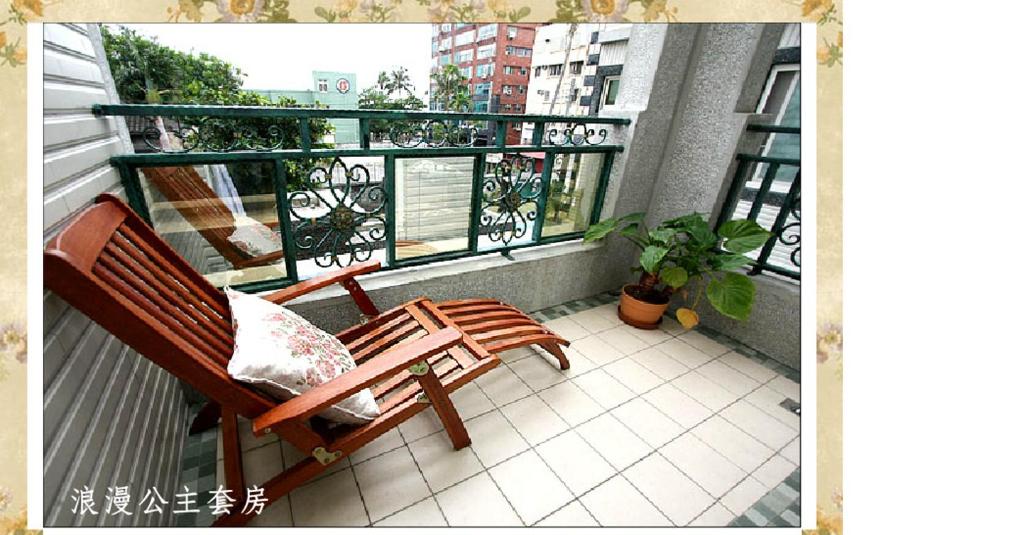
[{"left": 224, "top": 287, "right": 381, "bottom": 424}]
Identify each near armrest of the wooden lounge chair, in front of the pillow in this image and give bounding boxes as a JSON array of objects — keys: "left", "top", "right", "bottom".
[{"left": 253, "top": 327, "right": 463, "bottom": 435}]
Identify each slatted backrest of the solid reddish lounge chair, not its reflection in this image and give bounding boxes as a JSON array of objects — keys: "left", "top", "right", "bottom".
[{"left": 43, "top": 194, "right": 276, "bottom": 418}]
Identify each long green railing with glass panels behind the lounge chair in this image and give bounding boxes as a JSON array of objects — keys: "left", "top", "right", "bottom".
[{"left": 93, "top": 105, "right": 629, "bottom": 291}]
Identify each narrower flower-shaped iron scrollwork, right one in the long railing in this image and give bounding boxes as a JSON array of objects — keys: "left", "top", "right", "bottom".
[{"left": 480, "top": 156, "right": 544, "bottom": 245}]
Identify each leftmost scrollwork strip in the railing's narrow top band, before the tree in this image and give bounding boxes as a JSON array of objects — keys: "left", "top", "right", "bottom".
[{"left": 142, "top": 117, "right": 284, "bottom": 154}]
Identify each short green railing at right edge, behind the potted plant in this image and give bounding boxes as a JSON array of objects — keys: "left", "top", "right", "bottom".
[{"left": 718, "top": 124, "right": 801, "bottom": 280}]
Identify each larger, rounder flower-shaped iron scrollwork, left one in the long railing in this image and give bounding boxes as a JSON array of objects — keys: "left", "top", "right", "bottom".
[{"left": 289, "top": 158, "right": 388, "bottom": 268}]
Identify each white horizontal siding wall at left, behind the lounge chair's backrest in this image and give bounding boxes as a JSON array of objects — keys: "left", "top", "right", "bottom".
[{"left": 43, "top": 24, "right": 188, "bottom": 526}]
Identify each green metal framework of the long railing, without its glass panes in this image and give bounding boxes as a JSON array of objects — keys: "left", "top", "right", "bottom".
[{"left": 93, "top": 105, "right": 629, "bottom": 291}]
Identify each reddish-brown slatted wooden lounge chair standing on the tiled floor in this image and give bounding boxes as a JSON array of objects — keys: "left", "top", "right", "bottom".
[{"left": 43, "top": 194, "right": 568, "bottom": 526}]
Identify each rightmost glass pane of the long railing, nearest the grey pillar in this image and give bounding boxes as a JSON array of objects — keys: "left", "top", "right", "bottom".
[{"left": 542, "top": 154, "right": 604, "bottom": 237}]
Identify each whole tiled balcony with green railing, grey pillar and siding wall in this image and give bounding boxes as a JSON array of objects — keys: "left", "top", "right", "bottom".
[{"left": 43, "top": 25, "right": 813, "bottom": 527}]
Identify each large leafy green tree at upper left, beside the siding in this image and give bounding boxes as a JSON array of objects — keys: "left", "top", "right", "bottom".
[{"left": 100, "top": 26, "right": 334, "bottom": 191}]
